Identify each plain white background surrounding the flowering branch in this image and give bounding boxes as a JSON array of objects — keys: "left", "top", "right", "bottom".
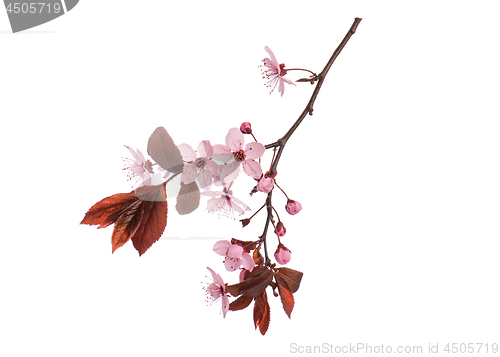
[{"left": 0, "top": 0, "right": 500, "bottom": 356}]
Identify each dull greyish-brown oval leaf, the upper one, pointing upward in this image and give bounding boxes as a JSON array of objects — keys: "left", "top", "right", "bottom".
[{"left": 148, "top": 126, "right": 184, "bottom": 174}]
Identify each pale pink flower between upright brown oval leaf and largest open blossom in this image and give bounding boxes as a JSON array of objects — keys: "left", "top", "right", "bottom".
[{"left": 177, "top": 140, "right": 216, "bottom": 190}]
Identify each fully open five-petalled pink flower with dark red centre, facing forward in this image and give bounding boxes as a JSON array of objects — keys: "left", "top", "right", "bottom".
[{"left": 213, "top": 128, "right": 266, "bottom": 184}]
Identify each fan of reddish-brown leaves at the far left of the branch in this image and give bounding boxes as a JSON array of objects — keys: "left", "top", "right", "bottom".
[{"left": 80, "top": 184, "right": 167, "bottom": 255}]
